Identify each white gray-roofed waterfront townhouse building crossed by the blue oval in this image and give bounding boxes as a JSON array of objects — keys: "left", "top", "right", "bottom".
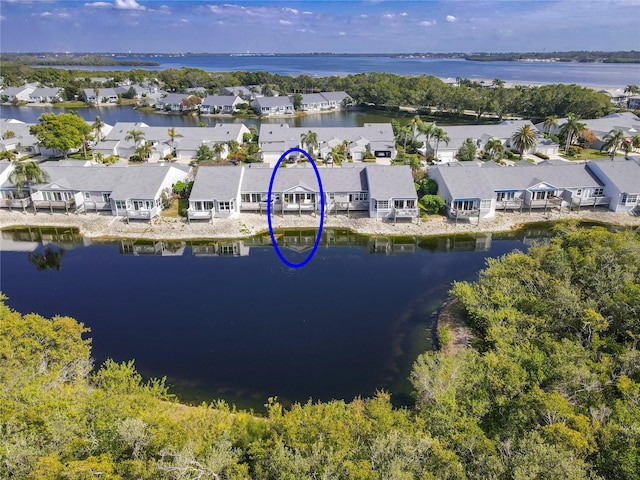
[{"left": 188, "top": 164, "right": 418, "bottom": 220}]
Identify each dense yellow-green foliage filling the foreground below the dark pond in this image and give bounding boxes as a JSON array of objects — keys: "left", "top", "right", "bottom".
[{"left": 0, "top": 225, "right": 640, "bottom": 480}]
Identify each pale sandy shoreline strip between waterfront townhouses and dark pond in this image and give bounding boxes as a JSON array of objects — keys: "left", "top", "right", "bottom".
[{"left": 0, "top": 209, "right": 640, "bottom": 241}]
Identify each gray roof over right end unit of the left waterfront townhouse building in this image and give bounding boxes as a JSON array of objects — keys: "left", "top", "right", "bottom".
[{"left": 111, "top": 163, "right": 188, "bottom": 200}]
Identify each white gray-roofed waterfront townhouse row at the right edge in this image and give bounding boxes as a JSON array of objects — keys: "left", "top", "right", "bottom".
[{"left": 428, "top": 157, "right": 640, "bottom": 219}]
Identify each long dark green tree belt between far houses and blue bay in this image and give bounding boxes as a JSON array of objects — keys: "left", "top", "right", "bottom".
[{"left": 2, "top": 62, "right": 613, "bottom": 119}]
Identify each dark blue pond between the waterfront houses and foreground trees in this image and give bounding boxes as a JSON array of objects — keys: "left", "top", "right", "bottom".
[{"left": 0, "top": 228, "right": 548, "bottom": 409}]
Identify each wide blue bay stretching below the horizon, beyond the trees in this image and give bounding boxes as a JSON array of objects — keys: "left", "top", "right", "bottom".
[{"left": 69, "top": 55, "right": 640, "bottom": 87}]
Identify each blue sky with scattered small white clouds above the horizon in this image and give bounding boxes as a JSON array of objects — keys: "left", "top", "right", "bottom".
[{"left": 0, "top": 0, "right": 640, "bottom": 53}]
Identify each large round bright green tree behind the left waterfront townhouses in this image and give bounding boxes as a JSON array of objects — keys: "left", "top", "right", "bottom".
[{"left": 29, "top": 113, "right": 91, "bottom": 158}]
